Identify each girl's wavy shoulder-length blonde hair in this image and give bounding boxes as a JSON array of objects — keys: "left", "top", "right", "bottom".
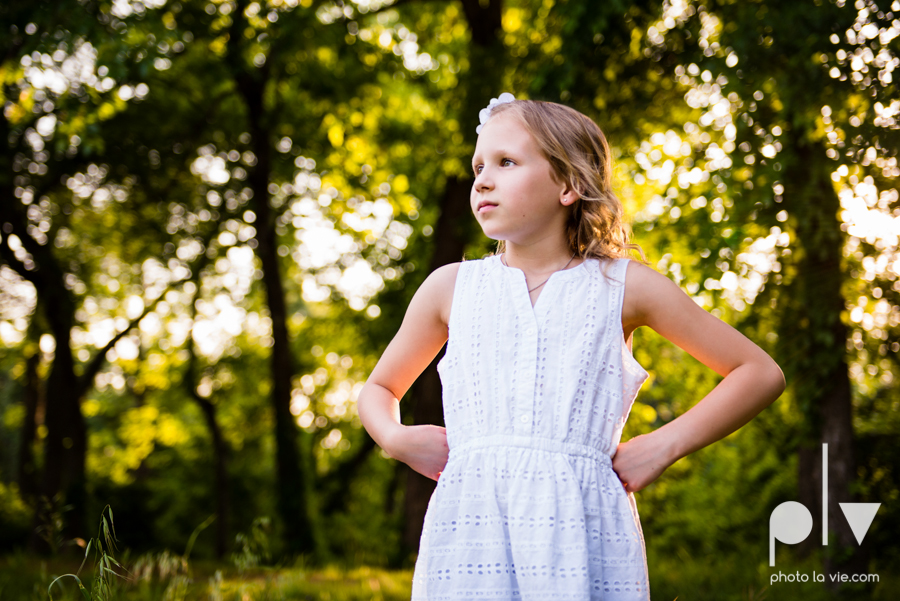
[{"left": 491, "top": 100, "right": 646, "bottom": 263}]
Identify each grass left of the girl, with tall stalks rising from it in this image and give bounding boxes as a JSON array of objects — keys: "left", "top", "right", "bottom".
[{"left": 0, "top": 507, "right": 412, "bottom": 601}]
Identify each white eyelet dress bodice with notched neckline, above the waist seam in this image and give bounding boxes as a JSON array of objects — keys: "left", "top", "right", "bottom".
[{"left": 438, "top": 256, "right": 647, "bottom": 456}]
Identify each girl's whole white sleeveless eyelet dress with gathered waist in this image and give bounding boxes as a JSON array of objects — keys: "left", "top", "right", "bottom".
[{"left": 412, "top": 256, "right": 650, "bottom": 601}]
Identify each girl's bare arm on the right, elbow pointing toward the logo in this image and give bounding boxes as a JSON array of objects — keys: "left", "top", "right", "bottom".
[{"left": 614, "top": 262, "right": 785, "bottom": 492}]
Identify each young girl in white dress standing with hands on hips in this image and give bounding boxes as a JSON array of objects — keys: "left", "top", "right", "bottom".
[{"left": 358, "top": 94, "right": 784, "bottom": 601}]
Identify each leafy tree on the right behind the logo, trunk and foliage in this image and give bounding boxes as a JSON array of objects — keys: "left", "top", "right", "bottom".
[{"left": 652, "top": 1, "right": 900, "bottom": 572}]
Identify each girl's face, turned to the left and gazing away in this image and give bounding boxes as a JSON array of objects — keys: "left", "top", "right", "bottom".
[{"left": 470, "top": 114, "right": 577, "bottom": 244}]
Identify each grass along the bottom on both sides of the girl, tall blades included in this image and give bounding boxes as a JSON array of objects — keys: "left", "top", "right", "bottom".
[{"left": 0, "top": 508, "right": 900, "bottom": 601}]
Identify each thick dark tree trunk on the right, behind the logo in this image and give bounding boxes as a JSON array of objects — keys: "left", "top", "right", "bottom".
[{"left": 779, "top": 134, "right": 868, "bottom": 582}]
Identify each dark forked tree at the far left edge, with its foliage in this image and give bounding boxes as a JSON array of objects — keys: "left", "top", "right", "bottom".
[{"left": 0, "top": 3, "right": 199, "bottom": 535}]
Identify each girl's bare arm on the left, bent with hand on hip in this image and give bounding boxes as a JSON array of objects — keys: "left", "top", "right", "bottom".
[{"left": 357, "top": 263, "right": 459, "bottom": 479}]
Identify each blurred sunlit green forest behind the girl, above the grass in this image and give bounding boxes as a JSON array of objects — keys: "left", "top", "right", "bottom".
[{"left": 0, "top": 0, "right": 900, "bottom": 599}]
